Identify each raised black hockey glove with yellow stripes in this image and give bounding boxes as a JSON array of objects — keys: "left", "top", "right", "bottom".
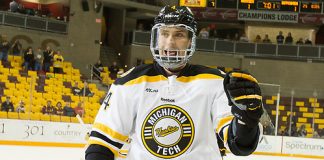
[{"left": 224, "top": 71, "right": 263, "bottom": 128}]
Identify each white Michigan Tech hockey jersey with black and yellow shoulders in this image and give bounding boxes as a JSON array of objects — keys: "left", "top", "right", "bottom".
[{"left": 89, "top": 64, "right": 260, "bottom": 160}]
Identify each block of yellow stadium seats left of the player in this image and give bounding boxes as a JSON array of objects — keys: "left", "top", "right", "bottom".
[{"left": 0, "top": 56, "right": 106, "bottom": 123}]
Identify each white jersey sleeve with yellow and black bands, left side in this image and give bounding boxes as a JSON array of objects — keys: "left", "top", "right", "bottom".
[{"left": 88, "top": 84, "right": 136, "bottom": 157}]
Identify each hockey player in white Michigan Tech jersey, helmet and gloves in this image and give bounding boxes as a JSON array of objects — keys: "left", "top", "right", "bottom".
[{"left": 86, "top": 6, "right": 263, "bottom": 160}]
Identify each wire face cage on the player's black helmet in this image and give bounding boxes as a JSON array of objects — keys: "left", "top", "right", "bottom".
[{"left": 150, "top": 23, "right": 196, "bottom": 69}]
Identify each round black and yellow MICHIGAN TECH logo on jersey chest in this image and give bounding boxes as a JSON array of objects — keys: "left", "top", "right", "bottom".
[{"left": 142, "top": 104, "right": 195, "bottom": 158}]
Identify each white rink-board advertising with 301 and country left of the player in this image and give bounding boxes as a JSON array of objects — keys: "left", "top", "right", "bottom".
[{"left": 0, "top": 119, "right": 91, "bottom": 144}]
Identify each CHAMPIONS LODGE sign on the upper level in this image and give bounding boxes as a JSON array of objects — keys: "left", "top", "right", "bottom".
[{"left": 238, "top": 10, "right": 298, "bottom": 23}]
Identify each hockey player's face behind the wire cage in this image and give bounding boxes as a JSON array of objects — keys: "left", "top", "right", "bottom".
[{"left": 158, "top": 26, "right": 191, "bottom": 56}]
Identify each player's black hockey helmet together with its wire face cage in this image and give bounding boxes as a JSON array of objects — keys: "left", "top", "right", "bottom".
[{"left": 150, "top": 6, "right": 197, "bottom": 69}]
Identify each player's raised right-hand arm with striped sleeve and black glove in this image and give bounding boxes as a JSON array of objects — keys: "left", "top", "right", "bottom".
[{"left": 215, "top": 72, "right": 263, "bottom": 156}]
